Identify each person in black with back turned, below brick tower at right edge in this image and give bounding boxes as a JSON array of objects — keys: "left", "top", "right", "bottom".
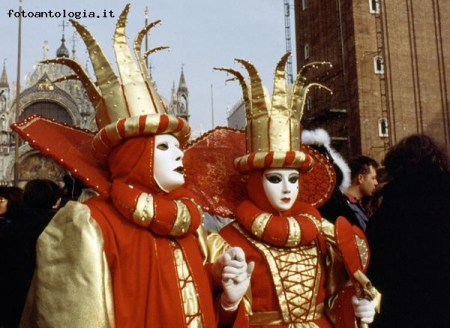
[{"left": 366, "top": 134, "right": 450, "bottom": 328}]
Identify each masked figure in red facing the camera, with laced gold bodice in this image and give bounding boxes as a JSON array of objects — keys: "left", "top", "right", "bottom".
[{"left": 214, "top": 53, "right": 375, "bottom": 328}]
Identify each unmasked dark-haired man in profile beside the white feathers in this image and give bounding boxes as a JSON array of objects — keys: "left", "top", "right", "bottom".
[{"left": 344, "top": 155, "right": 379, "bottom": 231}]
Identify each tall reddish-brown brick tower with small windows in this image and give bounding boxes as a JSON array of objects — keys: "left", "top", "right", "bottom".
[{"left": 295, "top": 0, "right": 450, "bottom": 160}]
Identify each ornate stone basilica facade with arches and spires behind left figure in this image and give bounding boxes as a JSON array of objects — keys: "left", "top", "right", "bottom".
[{"left": 0, "top": 35, "right": 189, "bottom": 187}]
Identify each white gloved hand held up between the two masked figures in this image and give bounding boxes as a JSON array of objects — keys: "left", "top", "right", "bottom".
[{"left": 214, "top": 247, "right": 255, "bottom": 311}]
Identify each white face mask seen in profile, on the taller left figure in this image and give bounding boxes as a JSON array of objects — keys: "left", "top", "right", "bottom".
[{"left": 153, "top": 134, "right": 184, "bottom": 192}]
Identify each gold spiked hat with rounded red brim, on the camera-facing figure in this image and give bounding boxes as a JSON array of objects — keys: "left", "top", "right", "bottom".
[{"left": 210, "top": 53, "right": 336, "bottom": 210}]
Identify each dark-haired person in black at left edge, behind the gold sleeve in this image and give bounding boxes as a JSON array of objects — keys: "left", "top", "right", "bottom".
[{"left": 0, "top": 179, "right": 62, "bottom": 328}]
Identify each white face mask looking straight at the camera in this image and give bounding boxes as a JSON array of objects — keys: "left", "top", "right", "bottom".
[{"left": 263, "top": 169, "right": 299, "bottom": 212}]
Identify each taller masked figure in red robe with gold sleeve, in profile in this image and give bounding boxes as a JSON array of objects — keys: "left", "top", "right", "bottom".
[{"left": 14, "top": 5, "right": 252, "bottom": 328}]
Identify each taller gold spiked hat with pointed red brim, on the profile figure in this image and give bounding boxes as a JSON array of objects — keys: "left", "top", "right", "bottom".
[{"left": 11, "top": 4, "right": 191, "bottom": 195}]
